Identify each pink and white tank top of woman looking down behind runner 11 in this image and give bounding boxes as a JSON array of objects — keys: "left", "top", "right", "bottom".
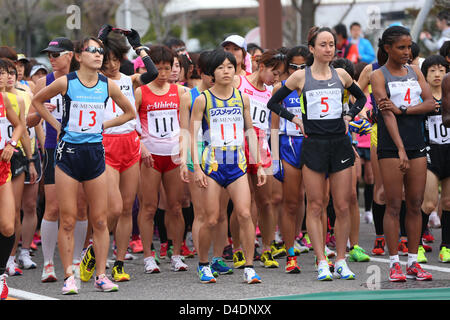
[{"left": 238, "top": 76, "right": 272, "bottom": 132}]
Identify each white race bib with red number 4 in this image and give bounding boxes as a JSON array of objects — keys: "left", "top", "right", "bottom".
[{"left": 388, "top": 79, "right": 422, "bottom": 107}]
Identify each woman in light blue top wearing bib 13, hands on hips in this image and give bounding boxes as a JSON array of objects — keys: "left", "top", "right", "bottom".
[{"left": 33, "top": 37, "right": 135, "bottom": 294}]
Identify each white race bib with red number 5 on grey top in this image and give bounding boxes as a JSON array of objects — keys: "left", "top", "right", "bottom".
[{"left": 306, "top": 88, "right": 342, "bottom": 120}]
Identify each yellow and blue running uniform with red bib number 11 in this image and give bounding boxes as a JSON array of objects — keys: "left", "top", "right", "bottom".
[{"left": 201, "top": 88, "right": 247, "bottom": 188}]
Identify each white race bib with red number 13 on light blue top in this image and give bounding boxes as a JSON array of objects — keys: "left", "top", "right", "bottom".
[{"left": 69, "top": 101, "right": 105, "bottom": 134}]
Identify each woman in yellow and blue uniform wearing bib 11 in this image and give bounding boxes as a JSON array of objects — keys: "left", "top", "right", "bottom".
[{"left": 190, "top": 49, "right": 266, "bottom": 283}]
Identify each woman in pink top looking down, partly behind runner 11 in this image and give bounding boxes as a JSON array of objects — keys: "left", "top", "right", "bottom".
[{"left": 230, "top": 50, "right": 286, "bottom": 268}]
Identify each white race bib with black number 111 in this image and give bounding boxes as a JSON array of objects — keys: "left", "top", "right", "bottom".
[{"left": 147, "top": 109, "right": 180, "bottom": 138}]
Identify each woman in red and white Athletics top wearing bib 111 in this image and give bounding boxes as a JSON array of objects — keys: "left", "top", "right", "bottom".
[{"left": 135, "top": 46, "right": 187, "bottom": 273}]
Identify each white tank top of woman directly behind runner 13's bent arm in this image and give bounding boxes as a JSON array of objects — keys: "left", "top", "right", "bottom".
[{"left": 103, "top": 73, "right": 136, "bottom": 134}]
